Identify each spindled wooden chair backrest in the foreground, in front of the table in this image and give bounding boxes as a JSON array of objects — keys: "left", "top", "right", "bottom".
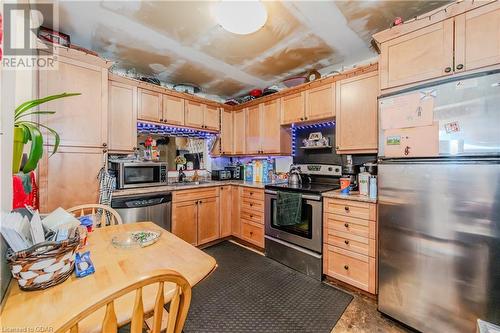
[{"left": 56, "top": 270, "right": 191, "bottom": 333}]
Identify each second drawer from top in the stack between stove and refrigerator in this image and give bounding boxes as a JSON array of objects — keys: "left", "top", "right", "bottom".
[{"left": 324, "top": 213, "right": 376, "bottom": 239}]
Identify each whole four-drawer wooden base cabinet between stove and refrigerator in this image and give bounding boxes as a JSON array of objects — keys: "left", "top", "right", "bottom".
[{"left": 323, "top": 198, "right": 377, "bottom": 294}]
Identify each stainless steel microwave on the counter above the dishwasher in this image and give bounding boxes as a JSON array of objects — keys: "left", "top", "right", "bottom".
[{"left": 110, "top": 161, "right": 168, "bottom": 189}]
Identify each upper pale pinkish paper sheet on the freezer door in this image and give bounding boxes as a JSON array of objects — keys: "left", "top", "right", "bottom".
[{"left": 379, "top": 89, "right": 436, "bottom": 130}]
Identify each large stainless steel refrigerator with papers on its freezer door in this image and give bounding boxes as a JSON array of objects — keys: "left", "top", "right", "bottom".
[{"left": 378, "top": 72, "right": 500, "bottom": 332}]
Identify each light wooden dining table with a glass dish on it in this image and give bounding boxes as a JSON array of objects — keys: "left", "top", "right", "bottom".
[{"left": 0, "top": 222, "right": 217, "bottom": 332}]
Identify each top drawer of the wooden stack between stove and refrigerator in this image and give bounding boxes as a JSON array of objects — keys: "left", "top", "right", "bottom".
[{"left": 324, "top": 198, "right": 377, "bottom": 221}]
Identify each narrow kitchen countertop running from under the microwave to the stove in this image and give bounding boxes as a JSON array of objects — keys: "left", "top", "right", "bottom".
[{"left": 113, "top": 180, "right": 266, "bottom": 197}]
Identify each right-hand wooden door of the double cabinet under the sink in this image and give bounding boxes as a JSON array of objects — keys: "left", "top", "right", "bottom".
[{"left": 198, "top": 197, "right": 220, "bottom": 245}]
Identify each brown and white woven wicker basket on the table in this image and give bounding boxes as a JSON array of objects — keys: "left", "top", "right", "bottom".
[{"left": 7, "top": 230, "right": 80, "bottom": 291}]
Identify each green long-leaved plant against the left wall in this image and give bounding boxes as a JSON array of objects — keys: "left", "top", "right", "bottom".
[{"left": 12, "top": 93, "right": 81, "bottom": 174}]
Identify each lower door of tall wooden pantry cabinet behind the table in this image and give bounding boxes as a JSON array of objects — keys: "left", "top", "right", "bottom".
[{"left": 38, "top": 146, "right": 106, "bottom": 213}]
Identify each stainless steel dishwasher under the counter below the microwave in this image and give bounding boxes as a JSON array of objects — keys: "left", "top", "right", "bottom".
[{"left": 111, "top": 192, "right": 172, "bottom": 231}]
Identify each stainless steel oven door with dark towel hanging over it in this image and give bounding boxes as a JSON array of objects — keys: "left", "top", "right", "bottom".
[{"left": 265, "top": 190, "right": 323, "bottom": 253}]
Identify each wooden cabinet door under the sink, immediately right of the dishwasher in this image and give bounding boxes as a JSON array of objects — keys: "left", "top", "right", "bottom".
[{"left": 172, "top": 201, "right": 198, "bottom": 246}]
